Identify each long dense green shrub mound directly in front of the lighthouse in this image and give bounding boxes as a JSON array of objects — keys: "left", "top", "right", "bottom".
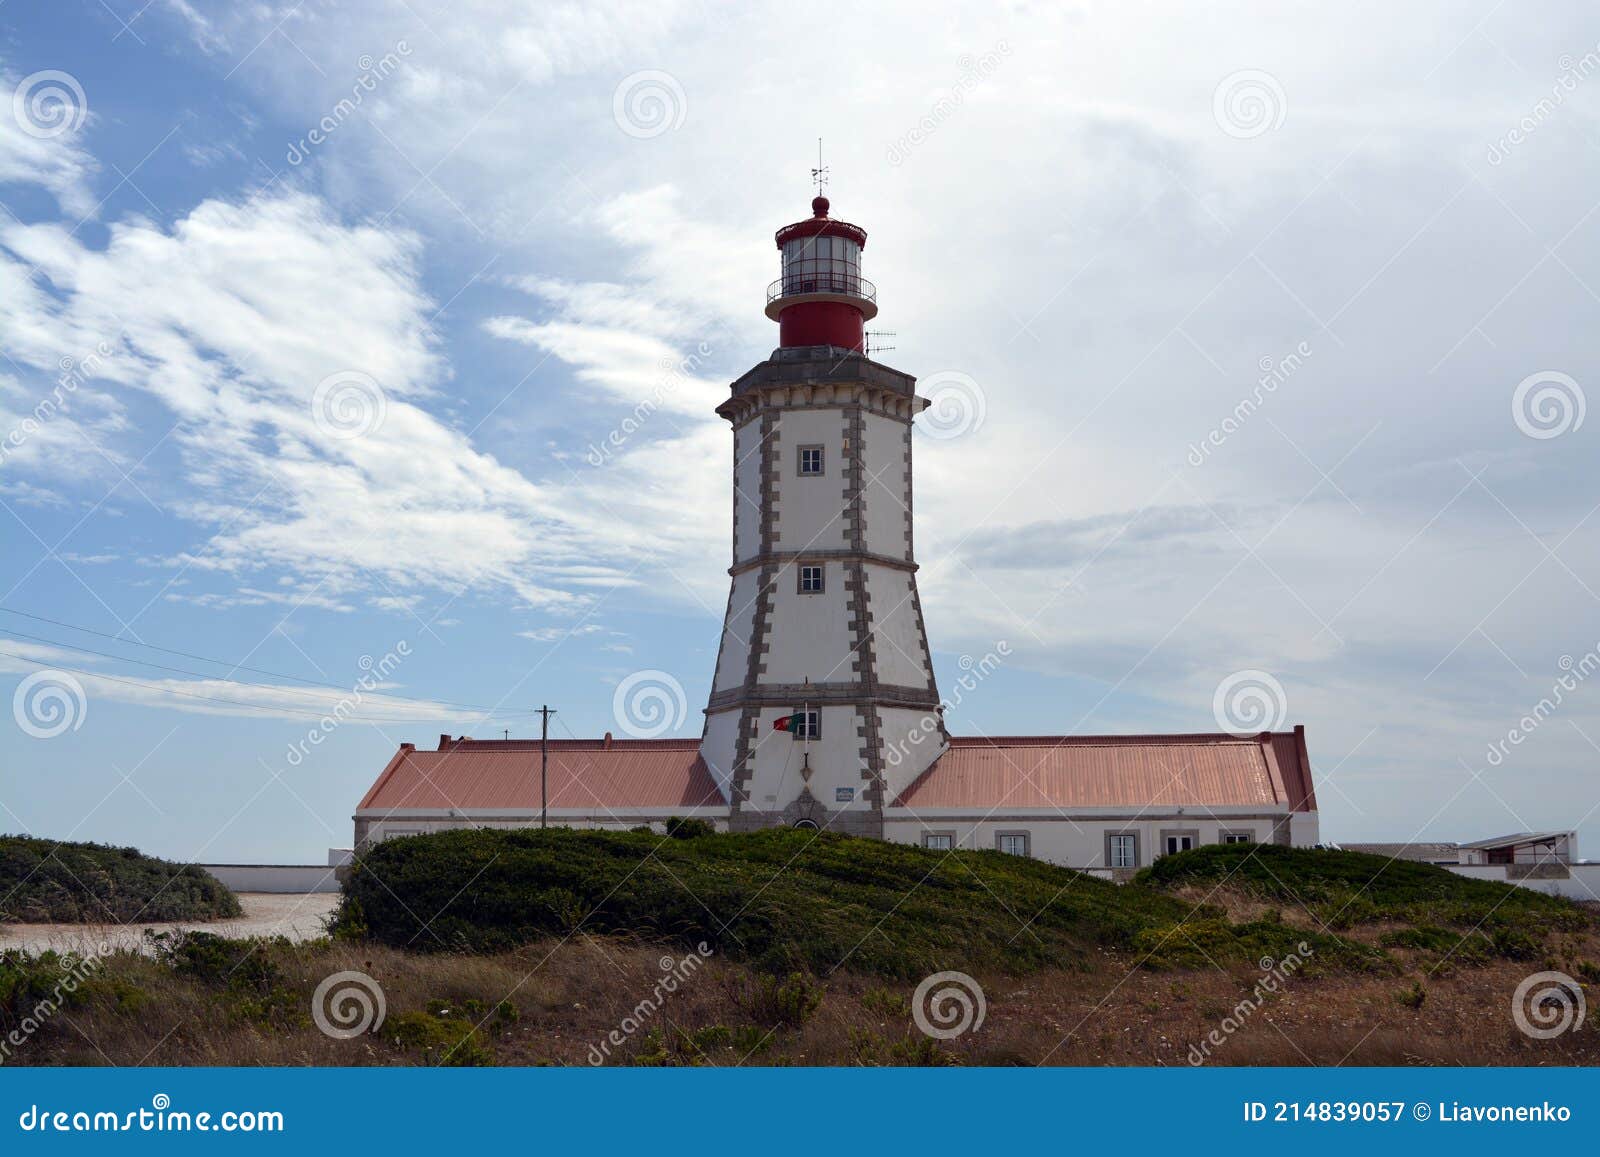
[{"left": 336, "top": 827, "right": 1384, "bottom": 978}]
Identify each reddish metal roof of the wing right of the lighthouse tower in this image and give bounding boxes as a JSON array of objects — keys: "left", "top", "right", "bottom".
[{"left": 891, "top": 727, "right": 1317, "bottom": 811}]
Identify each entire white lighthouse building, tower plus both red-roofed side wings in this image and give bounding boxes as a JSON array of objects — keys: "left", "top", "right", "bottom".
[{"left": 355, "top": 197, "right": 1317, "bottom": 872}]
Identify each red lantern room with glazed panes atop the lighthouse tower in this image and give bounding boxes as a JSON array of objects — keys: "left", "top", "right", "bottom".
[{"left": 766, "top": 197, "right": 878, "bottom": 350}]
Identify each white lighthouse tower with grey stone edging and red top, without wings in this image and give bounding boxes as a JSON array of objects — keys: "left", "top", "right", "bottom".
[{"left": 701, "top": 197, "right": 949, "bottom": 835}]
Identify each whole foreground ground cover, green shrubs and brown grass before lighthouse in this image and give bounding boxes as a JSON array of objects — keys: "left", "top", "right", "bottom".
[{"left": 0, "top": 824, "right": 1600, "bottom": 1066}]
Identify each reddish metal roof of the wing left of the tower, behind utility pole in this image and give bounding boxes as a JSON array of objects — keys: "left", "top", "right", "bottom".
[{"left": 358, "top": 739, "right": 723, "bottom": 811}]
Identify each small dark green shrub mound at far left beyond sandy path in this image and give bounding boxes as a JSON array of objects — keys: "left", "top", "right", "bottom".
[{"left": 0, "top": 835, "right": 240, "bottom": 923}]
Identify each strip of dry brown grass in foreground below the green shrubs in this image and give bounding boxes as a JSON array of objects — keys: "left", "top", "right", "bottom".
[{"left": 10, "top": 912, "right": 1600, "bottom": 1066}]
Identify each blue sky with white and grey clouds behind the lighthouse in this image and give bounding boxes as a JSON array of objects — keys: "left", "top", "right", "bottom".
[{"left": 0, "top": 0, "right": 1600, "bottom": 861}]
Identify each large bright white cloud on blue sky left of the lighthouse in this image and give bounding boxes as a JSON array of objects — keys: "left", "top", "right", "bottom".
[{"left": 0, "top": 185, "right": 707, "bottom": 607}]
